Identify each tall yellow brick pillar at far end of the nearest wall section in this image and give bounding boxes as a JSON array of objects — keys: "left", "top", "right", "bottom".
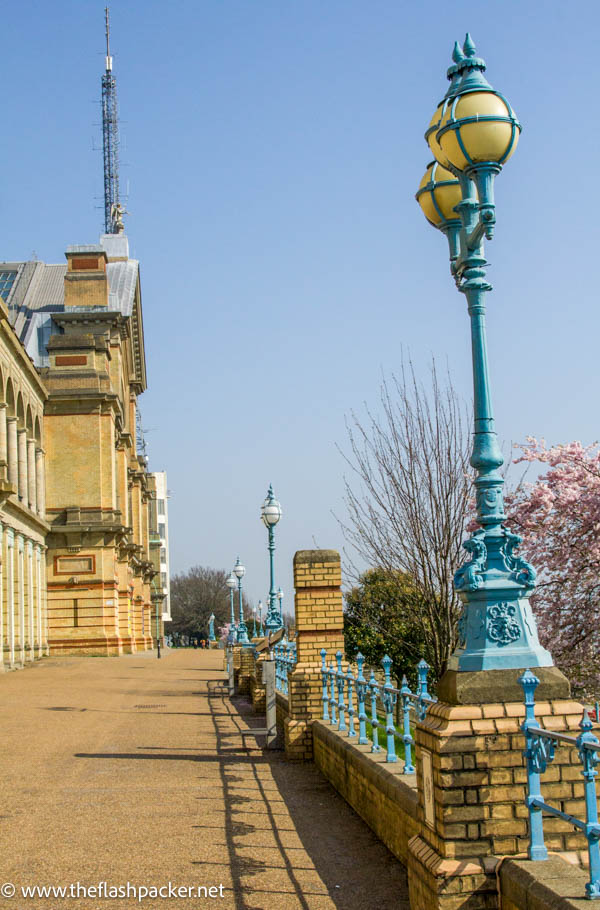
[{"left": 284, "top": 550, "right": 344, "bottom": 761}]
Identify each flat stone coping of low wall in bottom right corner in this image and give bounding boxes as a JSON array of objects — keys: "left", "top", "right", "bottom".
[{"left": 498, "top": 856, "right": 594, "bottom": 910}]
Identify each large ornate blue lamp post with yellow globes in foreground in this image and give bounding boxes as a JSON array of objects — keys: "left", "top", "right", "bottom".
[{"left": 417, "top": 35, "right": 552, "bottom": 671}]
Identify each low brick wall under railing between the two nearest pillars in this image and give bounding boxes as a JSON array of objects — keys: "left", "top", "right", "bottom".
[{"left": 312, "top": 720, "right": 420, "bottom": 865}]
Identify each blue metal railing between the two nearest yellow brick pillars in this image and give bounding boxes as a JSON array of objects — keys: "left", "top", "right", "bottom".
[{"left": 320, "top": 648, "right": 437, "bottom": 774}]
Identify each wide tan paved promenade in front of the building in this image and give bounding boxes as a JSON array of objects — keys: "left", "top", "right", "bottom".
[{"left": 0, "top": 650, "right": 409, "bottom": 910}]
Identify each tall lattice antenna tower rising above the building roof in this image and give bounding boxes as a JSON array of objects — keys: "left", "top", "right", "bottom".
[{"left": 102, "top": 7, "right": 125, "bottom": 234}]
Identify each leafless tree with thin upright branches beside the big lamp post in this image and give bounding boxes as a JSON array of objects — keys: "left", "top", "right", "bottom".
[{"left": 337, "top": 358, "right": 473, "bottom": 676}]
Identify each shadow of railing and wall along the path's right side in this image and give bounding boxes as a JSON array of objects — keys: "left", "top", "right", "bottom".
[{"left": 208, "top": 683, "right": 409, "bottom": 910}]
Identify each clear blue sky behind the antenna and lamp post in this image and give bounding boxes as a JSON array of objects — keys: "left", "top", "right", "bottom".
[{"left": 0, "top": 0, "right": 600, "bottom": 608}]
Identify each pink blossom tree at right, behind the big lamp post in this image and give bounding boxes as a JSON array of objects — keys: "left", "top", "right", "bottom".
[{"left": 506, "top": 437, "right": 600, "bottom": 696}]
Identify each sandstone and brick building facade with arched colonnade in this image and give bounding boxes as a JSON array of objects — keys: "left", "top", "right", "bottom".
[{"left": 0, "top": 233, "right": 164, "bottom": 667}]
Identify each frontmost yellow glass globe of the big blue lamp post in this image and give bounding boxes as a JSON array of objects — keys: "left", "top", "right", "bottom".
[{"left": 430, "top": 90, "right": 521, "bottom": 171}]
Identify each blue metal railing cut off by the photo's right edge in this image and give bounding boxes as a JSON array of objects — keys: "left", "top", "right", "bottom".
[{"left": 519, "top": 670, "right": 600, "bottom": 900}]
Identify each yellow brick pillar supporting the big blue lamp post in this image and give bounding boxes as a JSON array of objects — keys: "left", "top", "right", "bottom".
[{"left": 408, "top": 667, "right": 585, "bottom": 910}]
